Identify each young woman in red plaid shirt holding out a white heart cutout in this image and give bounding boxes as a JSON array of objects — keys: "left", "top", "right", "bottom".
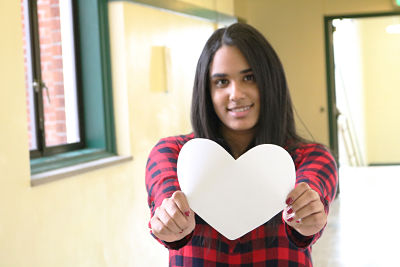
[{"left": 146, "top": 23, "right": 337, "bottom": 266}]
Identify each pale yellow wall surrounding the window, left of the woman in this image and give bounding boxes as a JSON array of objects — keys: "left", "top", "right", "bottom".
[{"left": 0, "top": 0, "right": 233, "bottom": 267}]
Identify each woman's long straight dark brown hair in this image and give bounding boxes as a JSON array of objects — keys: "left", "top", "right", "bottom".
[{"left": 191, "top": 23, "right": 305, "bottom": 151}]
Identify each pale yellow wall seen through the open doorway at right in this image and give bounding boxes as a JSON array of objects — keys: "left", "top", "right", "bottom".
[{"left": 359, "top": 16, "right": 400, "bottom": 163}]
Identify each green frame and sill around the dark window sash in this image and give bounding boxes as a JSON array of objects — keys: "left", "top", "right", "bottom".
[{"left": 30, "top": 0, "right": 116, "bottom": 185}]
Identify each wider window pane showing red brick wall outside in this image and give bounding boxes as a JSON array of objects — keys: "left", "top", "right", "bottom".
[{"left": 37, "top": 0, "right": 80, "bottom": 146}]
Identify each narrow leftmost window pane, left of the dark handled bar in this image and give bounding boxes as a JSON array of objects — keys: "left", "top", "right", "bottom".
[{"left": 21, "top": 0, "right": 37, "bottom": 150}]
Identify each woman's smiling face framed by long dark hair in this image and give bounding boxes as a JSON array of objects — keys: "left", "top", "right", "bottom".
[{"left": 210, "top": 45, "right": 260, "bottom": 138}]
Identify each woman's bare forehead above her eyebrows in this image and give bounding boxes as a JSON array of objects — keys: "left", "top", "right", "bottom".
[{"left": 210, "top": 45, "right": 250, "bottom": 75}]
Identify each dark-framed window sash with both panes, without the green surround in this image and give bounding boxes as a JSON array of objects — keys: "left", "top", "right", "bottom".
[{"left": 21, "top": 0, "right": 84, "bottom": 158}]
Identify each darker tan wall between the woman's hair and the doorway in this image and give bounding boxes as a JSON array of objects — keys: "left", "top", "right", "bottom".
[{"left": 235, "top": 0, "right": 393, "bottom": 144}]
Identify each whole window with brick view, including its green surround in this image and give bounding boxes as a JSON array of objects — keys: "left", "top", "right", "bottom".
[{"left": 21, "top": 0, "right": 115, "bottom": 182}]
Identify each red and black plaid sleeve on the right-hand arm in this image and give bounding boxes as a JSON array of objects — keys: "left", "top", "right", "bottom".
[{"left": 282, "top": 144, "right": 338, "bottom": 248}]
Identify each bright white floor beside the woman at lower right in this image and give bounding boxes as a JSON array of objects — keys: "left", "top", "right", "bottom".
[{"left": 313, "top": 166, "right": 400, "bottom": 267}]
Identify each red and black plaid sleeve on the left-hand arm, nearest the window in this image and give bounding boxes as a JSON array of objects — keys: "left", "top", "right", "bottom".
[{"left": 146, "top": 135, "right": 193, "bottom": 249}]
